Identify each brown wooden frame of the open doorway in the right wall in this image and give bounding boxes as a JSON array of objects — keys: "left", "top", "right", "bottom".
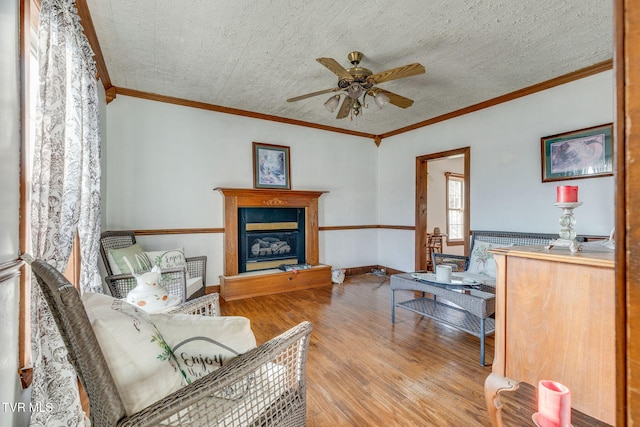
[{"left": 415, "top": 147, "right": 471, "bottom": 271}]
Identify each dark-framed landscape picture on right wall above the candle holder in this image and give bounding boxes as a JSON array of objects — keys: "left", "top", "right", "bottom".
[{"left": 541, "top": 123, "right": 613, "bottom": 182}]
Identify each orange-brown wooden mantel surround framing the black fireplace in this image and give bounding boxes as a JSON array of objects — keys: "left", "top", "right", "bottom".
[{"left": 215, "top": 187, "right": 331, "bottom": 299}]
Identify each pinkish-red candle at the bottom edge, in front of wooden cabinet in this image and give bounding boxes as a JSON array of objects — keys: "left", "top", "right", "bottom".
[{"left": 538, "top": 380, "right": 571, "bottom": 427}]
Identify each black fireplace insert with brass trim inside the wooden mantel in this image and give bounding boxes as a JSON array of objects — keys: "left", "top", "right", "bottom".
[{"left": 238, "top": 207, "right": 306, "bottom": 273}]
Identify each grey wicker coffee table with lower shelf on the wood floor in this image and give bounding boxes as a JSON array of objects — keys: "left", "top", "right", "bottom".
[{"left": 391, "top": 273, "right": 496, "bottom": 366}]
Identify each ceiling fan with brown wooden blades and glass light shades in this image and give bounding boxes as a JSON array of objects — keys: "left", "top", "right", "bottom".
[{"left": 287, "top": 52, "right": 425, "bottom": 119}]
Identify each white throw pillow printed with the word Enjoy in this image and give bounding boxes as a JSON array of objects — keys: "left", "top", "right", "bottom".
[{"left": 151, "top": 313, "right": 256, "bottom": 384}]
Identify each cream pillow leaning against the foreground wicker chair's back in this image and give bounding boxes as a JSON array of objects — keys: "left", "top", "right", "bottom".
[{"left": 82, "top": 292, "right": 184, "bottom": 415}]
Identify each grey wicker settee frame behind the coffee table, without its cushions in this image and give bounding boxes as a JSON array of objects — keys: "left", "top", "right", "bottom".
[{"left": 431, "top": 230, "right": 585, "bottom": 271}]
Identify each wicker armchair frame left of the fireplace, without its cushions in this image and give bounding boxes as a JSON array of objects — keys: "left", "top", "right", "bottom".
[{"left": 100, "top": 230, "right": 207, "bottom": 302}]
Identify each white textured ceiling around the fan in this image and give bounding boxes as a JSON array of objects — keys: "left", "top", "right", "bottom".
[{"left": 82, "top": 0, "right": 613, "bottom": 135}]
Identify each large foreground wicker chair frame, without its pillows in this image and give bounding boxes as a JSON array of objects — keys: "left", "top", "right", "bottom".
[{"left": 27, "top": 260, "right": 312, "bottom": 427}]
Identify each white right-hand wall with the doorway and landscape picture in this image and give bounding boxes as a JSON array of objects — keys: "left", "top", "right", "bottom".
[{"left": 378, "top": 71, "right": 615, "bottom": 271}]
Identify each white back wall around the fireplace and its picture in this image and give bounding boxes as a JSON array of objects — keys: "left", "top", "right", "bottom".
[{"left": 105, "top": 96, "right": 378, "bottom": 285}]
